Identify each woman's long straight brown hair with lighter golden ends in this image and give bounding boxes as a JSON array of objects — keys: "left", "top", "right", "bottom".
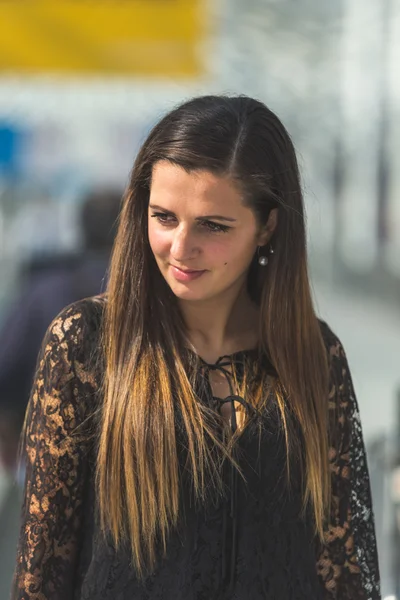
[{"left": 97, "top": 96, "right": 330, "bottom": 574}]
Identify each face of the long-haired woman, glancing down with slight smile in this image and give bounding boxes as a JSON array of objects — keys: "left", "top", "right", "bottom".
[{"left": 148, "top": 161, "right": 271, "bottom": 301}]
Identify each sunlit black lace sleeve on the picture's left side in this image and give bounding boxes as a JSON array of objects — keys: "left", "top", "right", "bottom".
[{"left": 11, "top": 303, "right": 95, "bottom": 600}]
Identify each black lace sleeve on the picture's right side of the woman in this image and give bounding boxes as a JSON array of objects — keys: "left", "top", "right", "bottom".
[{"left": 317, "top": 332, "right": 381, "bottom": 600}]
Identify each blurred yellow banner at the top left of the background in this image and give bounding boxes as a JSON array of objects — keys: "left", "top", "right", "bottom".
[{"left": 0, "top": 0, "right": 204, "bottom": 77}]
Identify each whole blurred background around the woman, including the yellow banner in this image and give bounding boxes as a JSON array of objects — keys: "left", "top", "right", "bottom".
[{"left": 0, "top": 0, "right": 400, "bottom": 600}]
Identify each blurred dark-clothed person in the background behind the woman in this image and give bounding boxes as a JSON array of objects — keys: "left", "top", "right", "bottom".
[{"left": 0, "top": 188, "right": 121, "bottom": 474}]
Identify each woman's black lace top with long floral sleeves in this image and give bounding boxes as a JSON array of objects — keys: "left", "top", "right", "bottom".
[{"left": 12, "top": 297, "right": 380, "bottom": 600}]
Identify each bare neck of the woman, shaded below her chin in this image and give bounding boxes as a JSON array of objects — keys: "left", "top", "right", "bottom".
[{"left": 180, "top": 290, "right": 259, "bottom": 363}]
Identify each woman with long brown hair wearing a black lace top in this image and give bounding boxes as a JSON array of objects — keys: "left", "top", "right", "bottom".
[{"left": 12, "top": 96, "right": 380, "bottom": 600}]
